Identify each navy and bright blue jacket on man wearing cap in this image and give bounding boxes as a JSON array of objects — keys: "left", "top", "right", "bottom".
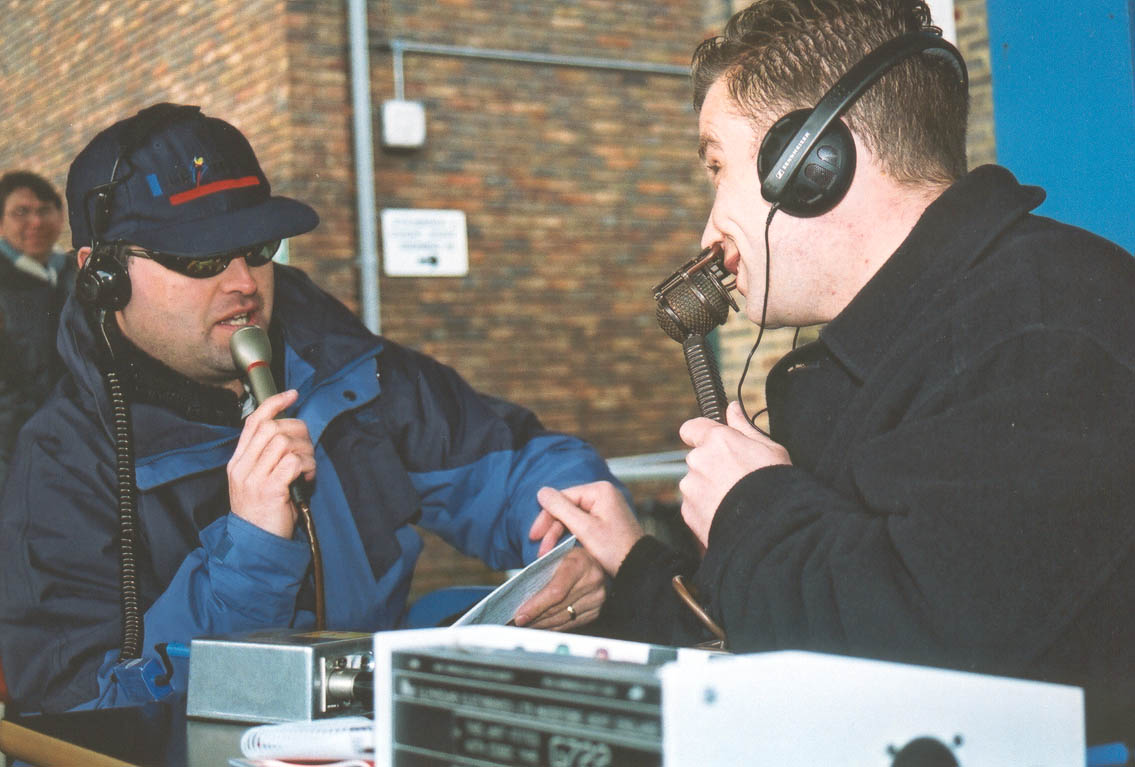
[{"left": 0, "top": 266, "right": 611, "bottom": 710}]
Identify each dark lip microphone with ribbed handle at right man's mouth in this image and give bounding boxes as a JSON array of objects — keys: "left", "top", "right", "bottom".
[{"left": 654, "top": 245, "right": 737, "bottom": 423}]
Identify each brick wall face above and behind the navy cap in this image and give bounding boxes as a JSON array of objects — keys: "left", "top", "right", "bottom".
[{"left": 0, "top": 0, "right": 301, "bottom": 244}]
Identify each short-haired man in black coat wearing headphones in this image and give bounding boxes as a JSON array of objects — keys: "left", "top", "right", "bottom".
[{"left": 539, "top": 0, "right": 1135, "bottom": 742}]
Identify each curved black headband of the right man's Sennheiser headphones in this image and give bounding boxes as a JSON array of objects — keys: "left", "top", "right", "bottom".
[{"left": 760, "top": 30, "right": 969, "bottom": 201}]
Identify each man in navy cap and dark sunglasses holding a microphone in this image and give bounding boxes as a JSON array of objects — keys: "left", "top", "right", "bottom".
[{"left": 0, "top": 104, "right": 612, "bottom": 711}]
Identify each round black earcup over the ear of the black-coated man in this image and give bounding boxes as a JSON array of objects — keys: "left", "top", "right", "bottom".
[{"left": 757, "top": 109, "right": 855, "bottom": 218}]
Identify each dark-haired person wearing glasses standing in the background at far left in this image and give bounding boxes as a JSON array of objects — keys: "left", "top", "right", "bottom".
[{"left": 0, "top": 170, "right": 75, "bottom": 487}]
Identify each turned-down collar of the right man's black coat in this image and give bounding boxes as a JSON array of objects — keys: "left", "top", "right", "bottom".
[{"left": 819, "top": 166, "right": 1044, "bottom": 380}]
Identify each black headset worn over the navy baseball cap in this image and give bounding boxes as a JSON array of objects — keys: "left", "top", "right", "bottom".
[{"left": 75, "top": 103, "right": 201, "bottom": 312}]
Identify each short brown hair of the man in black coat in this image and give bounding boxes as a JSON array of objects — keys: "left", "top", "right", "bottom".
[{"left": 693, "top": 0, "right": 968, "bottom": 185}]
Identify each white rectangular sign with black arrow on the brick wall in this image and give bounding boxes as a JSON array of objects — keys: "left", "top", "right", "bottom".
[{"left": 381, "top": 208, "right": 469, "bottom": 277}]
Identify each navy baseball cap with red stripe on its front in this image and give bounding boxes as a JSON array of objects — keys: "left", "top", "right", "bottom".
[{"left": 67, "top": 103, "right": 319, "bottom": 256}]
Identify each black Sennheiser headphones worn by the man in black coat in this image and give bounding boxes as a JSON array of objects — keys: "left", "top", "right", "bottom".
[{"left": 757, "top": 30, "right": 969, "bottom": 218}]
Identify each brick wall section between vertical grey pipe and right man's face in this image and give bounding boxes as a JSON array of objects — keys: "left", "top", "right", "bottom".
[{"left": 371, "top": 0, "right": 708, "bottom": 455}]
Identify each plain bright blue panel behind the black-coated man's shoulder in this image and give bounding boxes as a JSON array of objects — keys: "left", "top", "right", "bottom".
[{"left": 986, "top": 0, "right": 1135, "bottom": 251}]
